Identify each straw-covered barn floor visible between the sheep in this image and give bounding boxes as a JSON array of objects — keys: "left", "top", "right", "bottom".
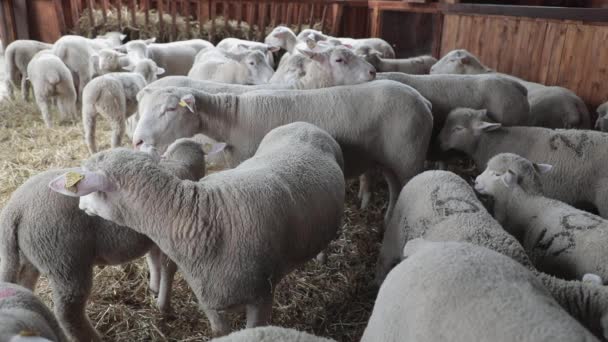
[{"left": 0, "top": 83, "right": 387, "bottom": 341}]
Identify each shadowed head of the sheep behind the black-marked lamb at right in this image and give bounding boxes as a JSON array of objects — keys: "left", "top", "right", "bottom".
[{"left": 439, "top": 108, "right": 501, "bottom": 153}]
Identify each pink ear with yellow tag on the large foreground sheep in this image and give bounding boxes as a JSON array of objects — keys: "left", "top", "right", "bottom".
[{"left": 49, "top": 169, "right": 116, "bottom": 197}]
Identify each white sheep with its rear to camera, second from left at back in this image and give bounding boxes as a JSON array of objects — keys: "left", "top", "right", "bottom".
[{"left": 27, "top": 50, "right": 77, "bottom": 128}]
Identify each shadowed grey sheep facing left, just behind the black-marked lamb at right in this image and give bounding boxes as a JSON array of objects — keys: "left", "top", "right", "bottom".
[{"left": 439, "top": 109, "right": 608, "bottom": 218}]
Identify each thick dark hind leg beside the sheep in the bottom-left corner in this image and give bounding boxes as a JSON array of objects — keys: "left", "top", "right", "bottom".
[{"left": 50, "top": 266, "right": 101, "bottom": 342}]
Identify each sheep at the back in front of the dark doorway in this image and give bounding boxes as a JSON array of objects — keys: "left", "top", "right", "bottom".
[{"left": 354, "top": 45, "right": 437, "bottom": 75}]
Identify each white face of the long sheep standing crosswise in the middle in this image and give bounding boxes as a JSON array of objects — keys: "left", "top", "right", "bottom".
[{"left": 133, "top": 89, "right": 201, "bottom": 154}]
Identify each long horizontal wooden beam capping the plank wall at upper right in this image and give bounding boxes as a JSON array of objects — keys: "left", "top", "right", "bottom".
[{"left": 439, "top": 4, "right": 608, "bottom": 22}]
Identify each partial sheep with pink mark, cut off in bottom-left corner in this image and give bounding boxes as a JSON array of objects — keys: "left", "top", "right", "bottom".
[{"left": 0, "top": 282, "right": 68, "bottom": 342}]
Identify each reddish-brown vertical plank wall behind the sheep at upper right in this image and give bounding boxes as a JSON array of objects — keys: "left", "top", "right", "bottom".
[{"left": 441, "top": 14, "right": 608, "bottom": 108}]
